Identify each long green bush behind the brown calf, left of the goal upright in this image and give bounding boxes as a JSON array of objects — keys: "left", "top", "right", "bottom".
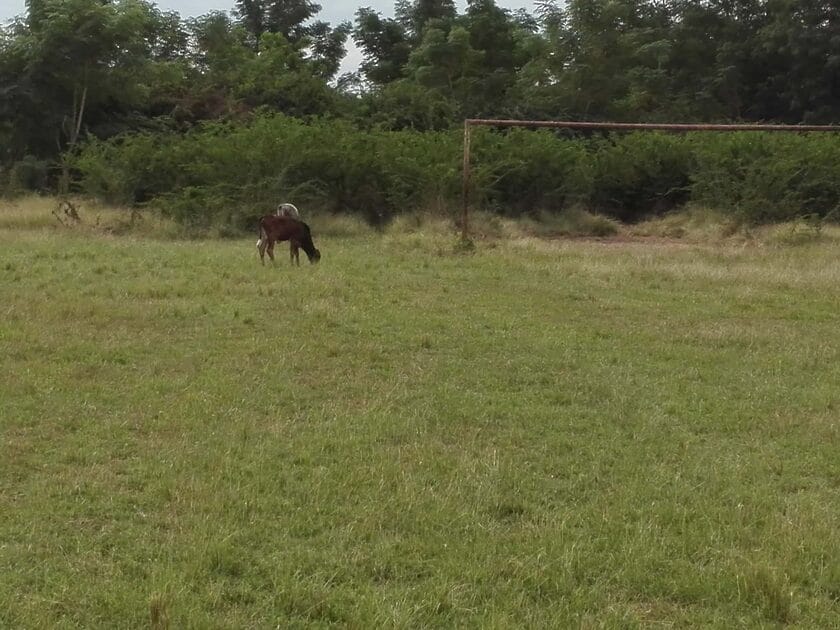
[{"left": 75, "top": 115, "right": 460, "bottom": 224}]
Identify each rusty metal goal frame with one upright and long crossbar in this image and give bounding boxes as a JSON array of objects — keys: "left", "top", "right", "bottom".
[{"left": 461, "top": 118, "right": 840, "bottom": 240}]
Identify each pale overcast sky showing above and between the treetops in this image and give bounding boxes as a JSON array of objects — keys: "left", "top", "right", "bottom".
[{"left": 0, "top": 0, "right": 534, "bottom": 72}]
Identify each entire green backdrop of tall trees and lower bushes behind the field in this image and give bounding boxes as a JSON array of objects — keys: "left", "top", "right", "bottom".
[{"left": 0, "top": 0, "right": 840, "bottom": 221}]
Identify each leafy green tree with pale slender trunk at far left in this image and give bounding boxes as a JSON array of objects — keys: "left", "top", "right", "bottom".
[{"left": 0, "top": 0, "right": 175, "bottom": 181}]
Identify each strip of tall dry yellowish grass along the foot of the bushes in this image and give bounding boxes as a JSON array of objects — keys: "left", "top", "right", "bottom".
[{"left": 0, "top": 195, "right": 840, "bottom": 249}]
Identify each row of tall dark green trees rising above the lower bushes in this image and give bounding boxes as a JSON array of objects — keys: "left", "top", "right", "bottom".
[{"left": 0, "top": 0, "right": 840, "bottom": 223}]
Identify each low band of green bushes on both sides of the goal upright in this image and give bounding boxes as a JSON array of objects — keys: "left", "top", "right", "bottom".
[{"left": 72, "top": 114, "right": 840, "bottom": 226}]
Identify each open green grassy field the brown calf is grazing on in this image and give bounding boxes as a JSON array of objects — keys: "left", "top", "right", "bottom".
[{"left": 0, "top": 204, "right": 840, "bottom": 628}]
